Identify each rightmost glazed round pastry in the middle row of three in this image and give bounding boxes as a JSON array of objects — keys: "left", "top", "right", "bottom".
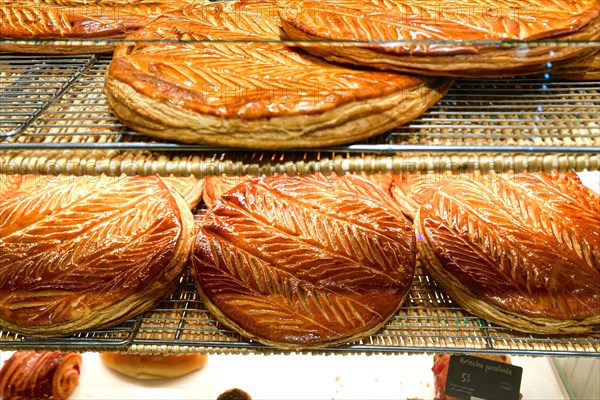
[{"left": 415, "top": 173, "right": 600, "bottom": 334}]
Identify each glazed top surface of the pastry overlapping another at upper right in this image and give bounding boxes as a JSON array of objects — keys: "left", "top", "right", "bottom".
[{"left": 280, "top": 0, "right": 600, "bottom": 54}]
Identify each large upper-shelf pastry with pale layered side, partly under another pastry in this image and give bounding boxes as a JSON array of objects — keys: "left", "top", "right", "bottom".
[{"left": 104, "top": 0, "right": 451, "bottom": 150}]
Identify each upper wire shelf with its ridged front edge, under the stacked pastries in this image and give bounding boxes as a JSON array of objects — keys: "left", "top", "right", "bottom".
[{"left": 0, "top": 55, "right": 600, "bottom": 176}]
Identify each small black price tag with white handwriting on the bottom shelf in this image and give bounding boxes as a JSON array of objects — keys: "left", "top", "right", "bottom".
[{"left": 446, "top": 355, "right": 523, "bottom": 400}]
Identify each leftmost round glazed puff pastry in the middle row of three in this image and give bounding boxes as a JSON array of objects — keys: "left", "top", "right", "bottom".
[{"left": 0, "top": 175, "right": 194, "bottom": 336}]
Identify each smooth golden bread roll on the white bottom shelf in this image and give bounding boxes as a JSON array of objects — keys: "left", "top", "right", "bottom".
[{"left": 100, "top": 353, "right": 208, "bottom": 380}]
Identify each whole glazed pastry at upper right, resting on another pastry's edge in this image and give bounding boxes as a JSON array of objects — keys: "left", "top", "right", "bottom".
[{"left": 280, "top": 0, "right": 600, "bottom": 77}]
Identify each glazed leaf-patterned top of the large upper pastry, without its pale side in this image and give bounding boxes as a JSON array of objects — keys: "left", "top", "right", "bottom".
[{"left": 108, "top": 0, "right": 424, "bottom": 120}]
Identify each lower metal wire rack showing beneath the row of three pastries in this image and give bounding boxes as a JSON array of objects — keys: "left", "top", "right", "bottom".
[{"left": 0, "top": 256, "right": 600, "bottom": 357}]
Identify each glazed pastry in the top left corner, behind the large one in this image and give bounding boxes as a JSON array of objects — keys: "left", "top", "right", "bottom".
[{"left": 0, "top": 0, "right": 203, "bottom": 54}]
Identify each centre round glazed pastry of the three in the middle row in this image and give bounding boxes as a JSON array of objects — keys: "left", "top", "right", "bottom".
[{"left": 191, "top": 175, "right": 416, "bottom": 349}]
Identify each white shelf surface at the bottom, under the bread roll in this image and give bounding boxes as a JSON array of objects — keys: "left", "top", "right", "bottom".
[{"left": 0, "top": 352, "right": 568, "bottom": 400}]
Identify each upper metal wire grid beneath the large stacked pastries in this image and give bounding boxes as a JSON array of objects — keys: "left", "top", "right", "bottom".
[{"left": 0, "top": 55, "right": 600, "bottom": 172}]
